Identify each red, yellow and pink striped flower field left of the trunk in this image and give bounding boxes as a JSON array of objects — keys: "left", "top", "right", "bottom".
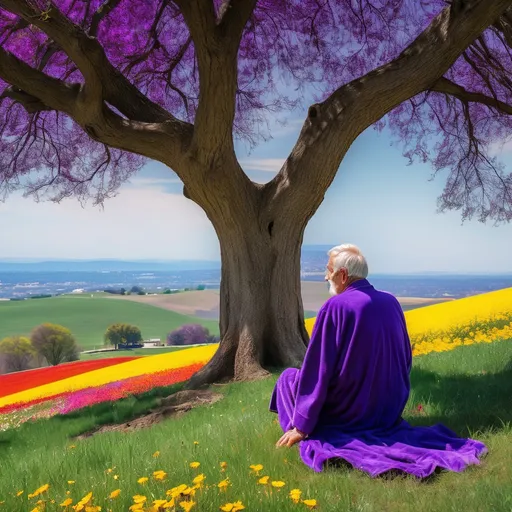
[{"left": 0, "top": 344, "right": 218, "bottom": 430}]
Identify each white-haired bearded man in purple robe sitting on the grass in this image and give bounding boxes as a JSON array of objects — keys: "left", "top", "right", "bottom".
[{"left": 270, "top": 244, "right": 487, "bottom": 478}]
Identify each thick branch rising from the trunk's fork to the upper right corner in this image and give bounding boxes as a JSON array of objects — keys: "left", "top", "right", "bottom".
[{"left": 265, "top": 0, "right": 512, "bottom": 222}]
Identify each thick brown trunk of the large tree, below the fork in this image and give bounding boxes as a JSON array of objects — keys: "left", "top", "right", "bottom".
[{"left": 187, "top": 201, "right": 308, "bottom": 388}]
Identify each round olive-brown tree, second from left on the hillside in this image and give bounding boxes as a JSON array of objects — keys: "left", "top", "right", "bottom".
[{"left": 30, "top": 323, "right": 79, "bottom": 366}]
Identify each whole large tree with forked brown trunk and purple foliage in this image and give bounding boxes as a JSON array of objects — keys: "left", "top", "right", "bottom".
[{"left": 0, "top": 0, "right": 512, "bottom": 385}]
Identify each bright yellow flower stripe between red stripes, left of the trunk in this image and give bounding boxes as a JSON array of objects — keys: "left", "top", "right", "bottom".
[{"left": 0, "top": 343, "right": 219, "bottom": 407}]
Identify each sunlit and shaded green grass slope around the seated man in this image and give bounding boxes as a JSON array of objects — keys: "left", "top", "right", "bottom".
[{"left": 0, "top": 341, "right": 512, "bottom": 512}]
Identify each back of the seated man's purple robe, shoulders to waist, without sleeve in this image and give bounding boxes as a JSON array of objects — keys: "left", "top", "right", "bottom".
[{"left": 312, "top": 279, "right": 411, "bottom": 431}]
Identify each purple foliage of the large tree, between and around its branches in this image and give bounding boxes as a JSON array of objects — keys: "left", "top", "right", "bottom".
[{"left": 0, "top": 0, "right": 512, "bottom": 220}]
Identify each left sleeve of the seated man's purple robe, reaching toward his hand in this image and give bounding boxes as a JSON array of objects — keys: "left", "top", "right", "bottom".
[{"left": 292, "top": 304, "right": 339, "bottom": 434}]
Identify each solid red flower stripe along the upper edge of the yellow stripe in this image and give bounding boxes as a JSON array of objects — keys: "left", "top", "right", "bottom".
[{"left": 0, "top": 356, "right": 140, "bottom": 398}]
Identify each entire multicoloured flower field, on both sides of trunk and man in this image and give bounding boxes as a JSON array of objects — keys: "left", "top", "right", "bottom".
[{"left": 0, "top": 288, "right": 512, "bottom": 430}]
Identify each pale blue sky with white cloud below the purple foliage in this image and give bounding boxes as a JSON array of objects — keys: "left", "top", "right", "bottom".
[{"left": 0, "top": 111, "right": 512, "bottom": 273}]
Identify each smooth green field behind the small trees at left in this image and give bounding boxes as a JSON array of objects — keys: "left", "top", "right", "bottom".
[{"left": 0, "top": 296, "right": 219, "bottom": 350}]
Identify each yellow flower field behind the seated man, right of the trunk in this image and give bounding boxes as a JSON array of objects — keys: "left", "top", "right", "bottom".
[{"left": 306, "top": 288, "right": 512, "bottom": 356}]
